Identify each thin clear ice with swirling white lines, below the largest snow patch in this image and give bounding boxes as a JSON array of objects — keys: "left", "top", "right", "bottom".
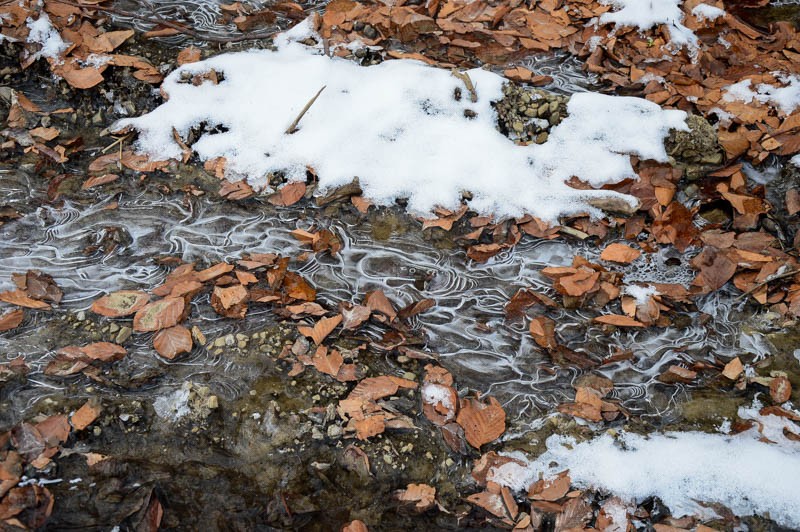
[{"left": 0, "top": 164, "right": 768, "bottom": 427}]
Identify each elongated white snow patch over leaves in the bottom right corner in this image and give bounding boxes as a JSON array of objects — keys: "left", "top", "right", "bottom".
[{"left": 489, "top": 405, "right": 800, "bottom": 528}]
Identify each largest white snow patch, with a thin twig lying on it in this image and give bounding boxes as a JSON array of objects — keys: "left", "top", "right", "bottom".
[{"left": 113, "top": 19, "right": 687, "bottom": 221}]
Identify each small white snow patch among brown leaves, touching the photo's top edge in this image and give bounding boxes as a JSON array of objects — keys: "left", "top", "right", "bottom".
[{"left": 600, "top": 0, "right": 698, "bottom": 53}]
